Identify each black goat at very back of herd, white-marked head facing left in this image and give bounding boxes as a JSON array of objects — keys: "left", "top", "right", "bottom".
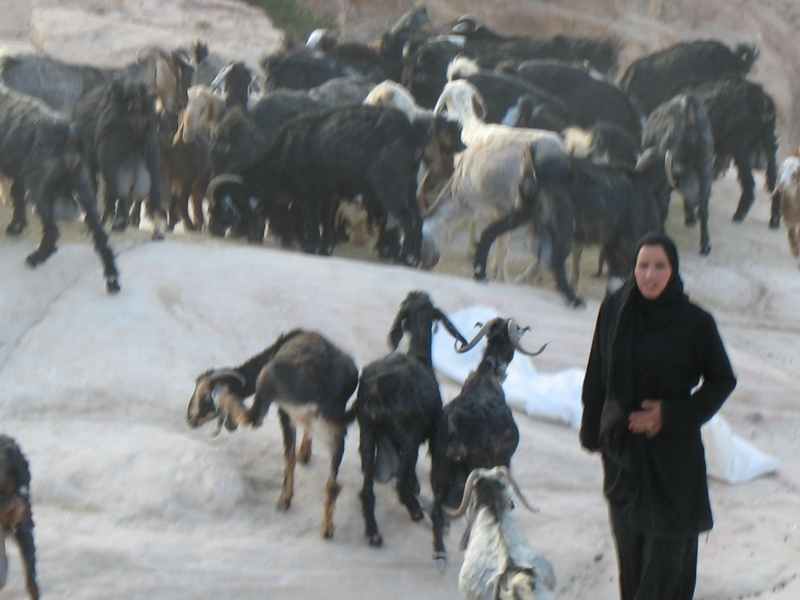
[{"left": 452, "top": 15, "right": 619, "bottom": 74}]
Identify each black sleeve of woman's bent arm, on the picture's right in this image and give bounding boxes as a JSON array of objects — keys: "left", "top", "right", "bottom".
[{"left": 661, "top": 313, "right": 736, "bottom": 435}]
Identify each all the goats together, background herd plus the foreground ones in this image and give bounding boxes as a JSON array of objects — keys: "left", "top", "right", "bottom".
[{"left": 0, "top": 8, "right": 800, "bottom": 600}]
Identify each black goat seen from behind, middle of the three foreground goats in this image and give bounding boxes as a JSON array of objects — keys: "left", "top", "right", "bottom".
[{"left": 355, "top": 292, "right": 467, "bottom": 546}]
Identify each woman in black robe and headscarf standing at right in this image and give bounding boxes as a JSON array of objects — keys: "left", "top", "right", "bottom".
[{"left": 580, "top": 233, "right": 736, "bottom": 600}]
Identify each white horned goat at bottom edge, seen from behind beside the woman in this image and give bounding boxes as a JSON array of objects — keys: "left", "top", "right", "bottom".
[{"left": 445, "top": 466, "right": 556, "bottom": 600}]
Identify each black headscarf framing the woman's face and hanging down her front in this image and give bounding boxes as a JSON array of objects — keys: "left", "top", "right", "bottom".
[{"left": 600, "top": 232, "right": 688, "bottom": 440}]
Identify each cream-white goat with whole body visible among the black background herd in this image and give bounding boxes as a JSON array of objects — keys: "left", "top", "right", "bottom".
[{"left": 423, "top": 80, "right": 567, "bottom": 279}]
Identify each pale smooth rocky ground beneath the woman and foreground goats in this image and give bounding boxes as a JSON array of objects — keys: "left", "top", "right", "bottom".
[{"left": 0, "top": 1, "right": 800, "bottom": 600}]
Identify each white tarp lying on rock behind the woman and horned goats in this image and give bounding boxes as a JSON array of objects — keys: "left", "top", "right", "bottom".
[{"left": 432, "top": 306, "right": 780, "bottom": 484}]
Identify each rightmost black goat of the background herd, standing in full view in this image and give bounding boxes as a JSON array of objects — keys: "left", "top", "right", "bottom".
[{"left": 687, "top": 77, "right": 780, "bottom": 222}]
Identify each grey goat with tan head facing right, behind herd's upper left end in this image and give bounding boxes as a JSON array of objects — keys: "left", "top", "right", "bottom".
[{"left": 0, "top": 48, "right": 193, "bottom": 115}]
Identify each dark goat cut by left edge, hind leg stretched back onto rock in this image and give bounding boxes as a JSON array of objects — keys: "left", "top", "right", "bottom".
[{"left": 0, "top": 88, "right": 120, "bottom": 294}]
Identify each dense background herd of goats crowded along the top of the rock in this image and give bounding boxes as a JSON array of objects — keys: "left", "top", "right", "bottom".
[{"left": 0, "top": 7, "right": 798, "bottom": 305}]
